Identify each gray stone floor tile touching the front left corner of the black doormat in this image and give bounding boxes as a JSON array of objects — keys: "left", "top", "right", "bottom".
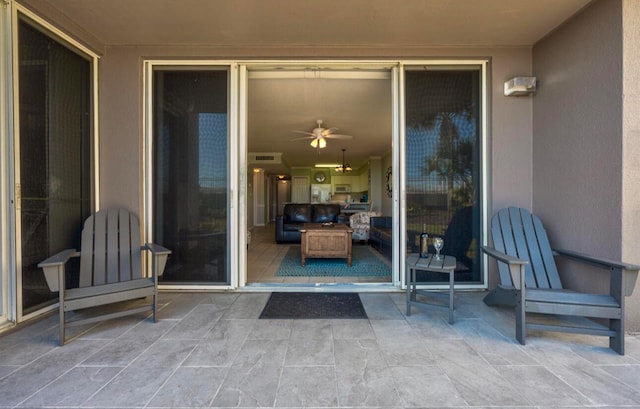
[{"left": 183, "top": 319, "right": 256, "bottom": 366}]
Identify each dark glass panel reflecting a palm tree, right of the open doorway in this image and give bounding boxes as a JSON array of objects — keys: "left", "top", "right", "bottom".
[{"left": 405, "top": 67, "right": 481, "bottom": 282}]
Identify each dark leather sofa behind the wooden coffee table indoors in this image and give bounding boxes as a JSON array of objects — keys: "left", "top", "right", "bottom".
[{"left": 276, "top": 203, "right": 348, "bottom": 243}]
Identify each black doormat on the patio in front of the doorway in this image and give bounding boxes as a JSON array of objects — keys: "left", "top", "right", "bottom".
[{"left": 260, "top": 292, "right": 367, "bottom": 319}]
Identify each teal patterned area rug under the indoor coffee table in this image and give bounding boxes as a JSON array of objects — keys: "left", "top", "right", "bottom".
[{"left": 276, "top": 246, "right": 391, "bottom": 277}]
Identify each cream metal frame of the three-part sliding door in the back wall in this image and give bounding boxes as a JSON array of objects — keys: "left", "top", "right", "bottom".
[{"left": 141, "top": 58, "right": 489, "bottom": 290}]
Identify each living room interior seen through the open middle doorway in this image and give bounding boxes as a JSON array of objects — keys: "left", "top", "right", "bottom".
[{"left": 247, "top": 65, "right": 392, "bottom": 283}]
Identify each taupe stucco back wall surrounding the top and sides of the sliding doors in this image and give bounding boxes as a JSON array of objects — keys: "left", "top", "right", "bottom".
[{"left": 100, "top": 47, "right": 532, "bottom": 217}]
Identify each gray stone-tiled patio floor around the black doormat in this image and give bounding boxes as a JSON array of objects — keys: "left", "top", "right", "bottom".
[{"left": 0, "top": 292, "right": 640, "bottom": 408}]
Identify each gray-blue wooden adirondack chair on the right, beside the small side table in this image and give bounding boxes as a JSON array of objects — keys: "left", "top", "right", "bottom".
[{"left": 482, "top": 207, "right": 640, "bottom": 355}]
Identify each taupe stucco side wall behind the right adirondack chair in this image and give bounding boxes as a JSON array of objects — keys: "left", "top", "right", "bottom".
[{"left": 533, "top": 0, "right": 638, "bottom": 329}]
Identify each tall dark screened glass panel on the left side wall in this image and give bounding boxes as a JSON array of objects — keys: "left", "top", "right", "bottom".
[{"left": 18, "top": 19, "right": 92, "bottom": 314}]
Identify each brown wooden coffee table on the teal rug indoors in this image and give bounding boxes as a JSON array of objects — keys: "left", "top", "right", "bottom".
[{"left": 300, "top": 223, "right": 353, "bottom": 267}]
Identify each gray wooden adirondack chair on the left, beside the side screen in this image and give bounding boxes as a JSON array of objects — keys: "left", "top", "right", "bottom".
[{"left": 38, "top": 209, "right": 171, "bottom": 345}]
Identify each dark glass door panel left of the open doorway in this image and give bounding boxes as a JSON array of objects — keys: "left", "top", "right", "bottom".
[{"left": 151, "top": 66, "right": 230, "bottom": 285}]
